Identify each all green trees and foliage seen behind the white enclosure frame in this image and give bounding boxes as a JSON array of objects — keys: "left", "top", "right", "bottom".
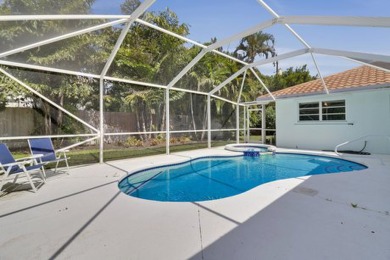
[{"left": 0, "top": 0, "right": 313, "bottom": 142}]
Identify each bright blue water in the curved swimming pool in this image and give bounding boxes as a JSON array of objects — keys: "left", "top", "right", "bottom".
[{"left": 119, "top": 153, "right": 367, "bottom": 201}]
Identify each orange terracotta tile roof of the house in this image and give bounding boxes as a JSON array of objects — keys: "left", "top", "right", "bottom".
[{"left": 258, "top": 66, "right": 390, "bottom": 100}]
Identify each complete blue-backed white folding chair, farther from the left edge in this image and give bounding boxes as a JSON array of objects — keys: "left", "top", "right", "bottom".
[{"left": 28, "top": 138, "right": 69, "bottom": 173}]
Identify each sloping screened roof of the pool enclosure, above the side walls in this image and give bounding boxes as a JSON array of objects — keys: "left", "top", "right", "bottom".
[{"left": 0, "top": 0, "right": 390, "bottom": 102}]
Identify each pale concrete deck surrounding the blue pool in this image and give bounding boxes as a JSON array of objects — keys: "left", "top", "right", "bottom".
[{"left": 0, "top": 148, "right": 390, "bottom": 260}]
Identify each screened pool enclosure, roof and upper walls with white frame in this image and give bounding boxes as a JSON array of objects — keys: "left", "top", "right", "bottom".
[{"left": 0, "top": 0, "right": 390, "bottom": 162}]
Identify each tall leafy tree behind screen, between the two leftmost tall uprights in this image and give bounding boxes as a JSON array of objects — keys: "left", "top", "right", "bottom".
[{"left": 105, "top": 6, "right": 190, "bottom": 139}]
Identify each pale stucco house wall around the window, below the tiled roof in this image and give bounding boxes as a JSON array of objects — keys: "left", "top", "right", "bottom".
[{"left": 276, "top": 89, "right": 390, "bottom": 154}]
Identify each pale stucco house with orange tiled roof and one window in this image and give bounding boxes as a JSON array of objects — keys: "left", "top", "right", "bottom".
[{"left": 257, "top": 64, "right": 390, "bottom": 154}]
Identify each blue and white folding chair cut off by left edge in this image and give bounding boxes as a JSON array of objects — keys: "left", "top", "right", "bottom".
[{"left": 0, "top": 143, "right": 46, "bottom": 192}]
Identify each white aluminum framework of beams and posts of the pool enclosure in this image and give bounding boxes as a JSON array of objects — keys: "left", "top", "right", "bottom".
[{"left": 0, "top": 0, "right": 390, "bottom": 162}]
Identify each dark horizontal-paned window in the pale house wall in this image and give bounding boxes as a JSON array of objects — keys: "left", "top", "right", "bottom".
[{"left": 299, "top": 100, "right": 346, "bottom": 121}]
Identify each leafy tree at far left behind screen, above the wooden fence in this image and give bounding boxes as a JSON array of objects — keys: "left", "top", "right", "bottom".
[{"left": 0, "top": 0, "right": 108, "bottom": 134}]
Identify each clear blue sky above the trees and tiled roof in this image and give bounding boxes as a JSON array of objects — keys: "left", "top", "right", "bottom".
[{"left": 94, "top": 0, "right": 390, "bottom": 75}]
